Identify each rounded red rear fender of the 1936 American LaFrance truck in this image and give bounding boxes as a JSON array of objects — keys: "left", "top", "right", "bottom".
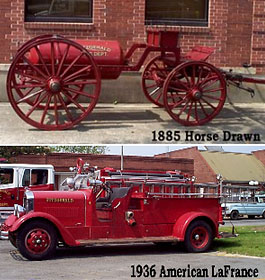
[{"left": 173, "top": 212, "right": 218, "bottom": 241}]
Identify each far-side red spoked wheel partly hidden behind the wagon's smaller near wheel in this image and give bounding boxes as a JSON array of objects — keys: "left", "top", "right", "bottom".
[{"left": 142, "top": 55, "right": 174, "bottom": 107}]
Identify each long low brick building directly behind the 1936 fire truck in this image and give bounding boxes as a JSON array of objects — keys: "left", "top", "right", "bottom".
[{"left": 10, "top": 153, "right": 194, "bottom": 186}]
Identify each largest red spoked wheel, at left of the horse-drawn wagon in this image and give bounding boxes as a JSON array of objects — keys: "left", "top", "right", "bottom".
[{"left": 7, "top": 37, "right": 101, "bottom": 130}]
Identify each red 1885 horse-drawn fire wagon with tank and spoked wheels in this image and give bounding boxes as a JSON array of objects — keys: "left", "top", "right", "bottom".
[{"left": 7, "top": 31, "right": 265, "bottom": 130}]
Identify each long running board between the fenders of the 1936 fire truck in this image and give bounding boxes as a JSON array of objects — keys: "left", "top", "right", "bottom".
[{"left": 77, "top": 236, "right": 180, "bottom": 245}]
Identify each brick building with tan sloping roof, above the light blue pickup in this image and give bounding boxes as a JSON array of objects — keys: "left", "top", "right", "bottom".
[{"left": 155, "top": 147, "right": 265, "bottom": 186}]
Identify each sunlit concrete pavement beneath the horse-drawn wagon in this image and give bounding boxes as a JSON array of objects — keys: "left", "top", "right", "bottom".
[{"left": 0, "top": 102, "right": 265, "bottom": 145}]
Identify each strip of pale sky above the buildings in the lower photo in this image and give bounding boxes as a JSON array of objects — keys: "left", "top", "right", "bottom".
[{"left": 106, "top": 144, "right": 265, "bottom": 156}]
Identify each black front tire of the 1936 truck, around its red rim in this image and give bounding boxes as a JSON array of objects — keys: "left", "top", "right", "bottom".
[{"left": 17, "top": 220, "right": 57, "bottom": 261}]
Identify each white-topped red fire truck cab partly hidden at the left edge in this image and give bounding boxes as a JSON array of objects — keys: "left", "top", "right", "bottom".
[{"left": 0, "top": 164, "right": 54, "bottom": 217}]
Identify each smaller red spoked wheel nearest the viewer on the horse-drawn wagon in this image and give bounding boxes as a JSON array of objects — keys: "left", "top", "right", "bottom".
[{"left": 163, "top": 61, "right": 227, "bottom": 126}]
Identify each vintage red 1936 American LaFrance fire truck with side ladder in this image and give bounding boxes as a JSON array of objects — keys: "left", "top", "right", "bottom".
[{"left": 1, "top": 162, "right": 223, "bottom": 260}]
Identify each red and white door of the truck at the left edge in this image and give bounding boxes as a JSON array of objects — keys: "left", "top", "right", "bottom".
[{"left": 0, "top": 167, "right": 18, "bottom": 207}]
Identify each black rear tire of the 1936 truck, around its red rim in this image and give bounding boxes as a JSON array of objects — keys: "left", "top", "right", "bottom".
[{"left": 184, "top": 220, "right": 213, "bottom": 253}]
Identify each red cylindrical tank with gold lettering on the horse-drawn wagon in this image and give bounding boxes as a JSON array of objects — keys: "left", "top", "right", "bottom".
[{"left": 28, "top": 40, "right": 124, "bottom": 79}]
